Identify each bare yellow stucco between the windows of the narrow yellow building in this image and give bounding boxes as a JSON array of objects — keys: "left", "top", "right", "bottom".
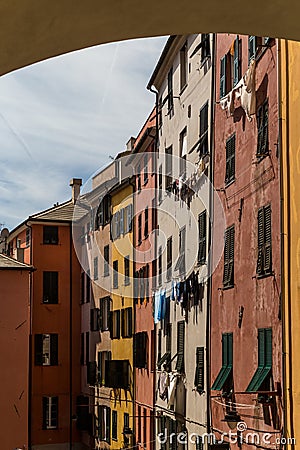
[{"left": 111, "top": 185, "right": 134, "bottom": 449}]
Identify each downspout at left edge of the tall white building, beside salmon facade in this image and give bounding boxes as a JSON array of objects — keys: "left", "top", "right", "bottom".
[{"left": 147, "top": 84, "right": 159, "bottom": 448}]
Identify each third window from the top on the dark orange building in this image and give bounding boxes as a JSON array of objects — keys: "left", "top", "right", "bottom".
[{"left": 34, "top": 334, "right": 58, "bottom": 366}]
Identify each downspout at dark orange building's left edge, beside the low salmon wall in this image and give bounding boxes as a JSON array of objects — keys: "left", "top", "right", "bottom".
[{"left": 25, "top": 221, "right": 33, "bottom": 450}]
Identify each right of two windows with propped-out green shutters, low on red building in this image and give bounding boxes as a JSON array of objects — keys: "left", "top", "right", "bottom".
[{"left": 246, "top": 328, "right": 272, "bottom": 392}]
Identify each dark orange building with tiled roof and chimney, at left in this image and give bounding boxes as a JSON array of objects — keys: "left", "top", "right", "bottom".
[{"left": 8, "top": 180, "right": 82, "bottom": 450}]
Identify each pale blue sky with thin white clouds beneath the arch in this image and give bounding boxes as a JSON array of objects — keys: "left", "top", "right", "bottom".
[{"left": 0, "top": 37, "right": 166, "bottom": 230}]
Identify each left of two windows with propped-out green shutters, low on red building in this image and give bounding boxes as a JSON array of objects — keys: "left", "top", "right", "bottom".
[{"left": 211, "top": 333, "right": 233, "bottom": 392}]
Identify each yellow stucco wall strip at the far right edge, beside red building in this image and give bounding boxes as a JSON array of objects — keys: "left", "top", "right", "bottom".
[{"left": 279, "top": 41, "right": 300, "bottom": 448}]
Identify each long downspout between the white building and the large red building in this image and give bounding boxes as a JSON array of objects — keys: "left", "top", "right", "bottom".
[{"left": 206, "top": 33, "right": 216, "bottom": 433}]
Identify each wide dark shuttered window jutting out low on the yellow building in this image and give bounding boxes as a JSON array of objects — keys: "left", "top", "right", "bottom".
[{"left": 105, "top": 359, "right": 129, "bottom": 389}]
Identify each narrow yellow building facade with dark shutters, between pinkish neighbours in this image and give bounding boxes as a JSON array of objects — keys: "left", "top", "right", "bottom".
[{"left": 108, "top": 181, "right": 134, "bottom": 449}]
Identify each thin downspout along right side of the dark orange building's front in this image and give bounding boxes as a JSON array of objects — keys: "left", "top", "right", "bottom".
[{"left": 69, "top": 222, "right": 73, "bottom": 450}]
